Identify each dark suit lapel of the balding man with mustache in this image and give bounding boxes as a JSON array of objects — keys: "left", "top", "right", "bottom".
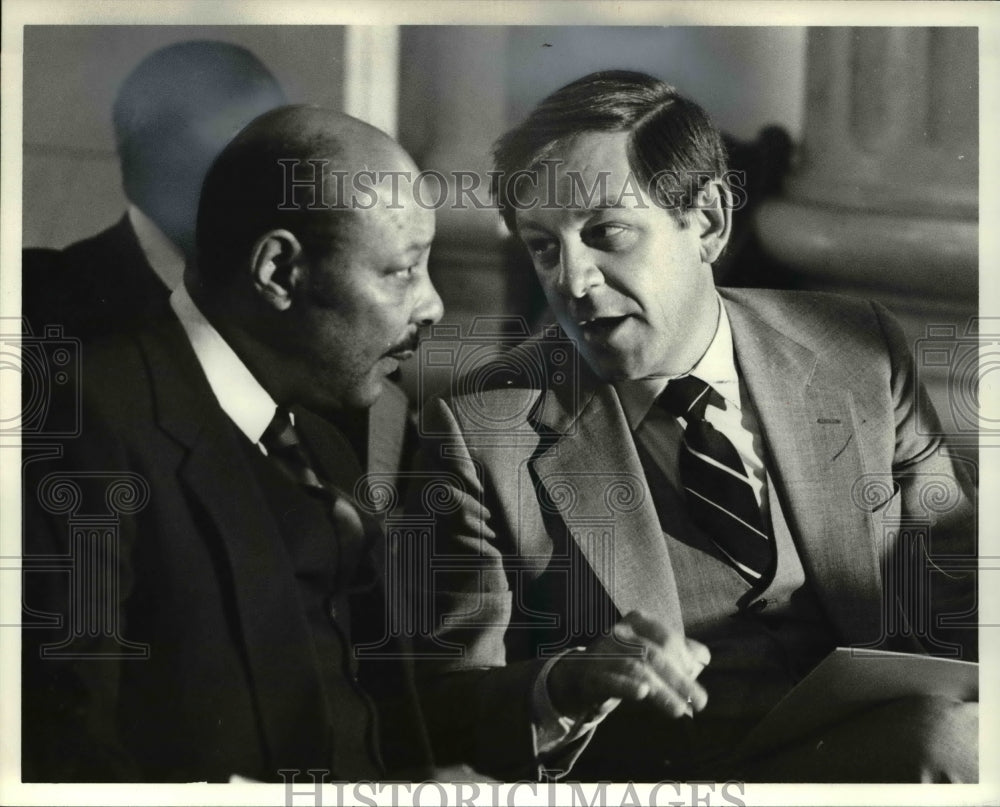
[{"left": 141, "top": 320, "right": 328, "bottom": 764}]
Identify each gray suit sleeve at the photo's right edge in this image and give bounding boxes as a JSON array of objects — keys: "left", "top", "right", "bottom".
[{"left": 874, "top": 304, "right": 978, "bottom": 660}]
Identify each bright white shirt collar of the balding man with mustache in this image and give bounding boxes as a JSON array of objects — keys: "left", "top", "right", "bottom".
[{"left": 170, "top": 283, "right": 277, "bottom": 443}]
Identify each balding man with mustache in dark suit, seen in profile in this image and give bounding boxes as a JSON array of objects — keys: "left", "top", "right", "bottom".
[{"left": 22, "top": 107, "right": 442, "bottom": 782}]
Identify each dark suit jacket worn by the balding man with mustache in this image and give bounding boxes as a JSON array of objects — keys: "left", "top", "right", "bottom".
[{"left": 22, "top": 319, "right": 428, "bottom": 781}]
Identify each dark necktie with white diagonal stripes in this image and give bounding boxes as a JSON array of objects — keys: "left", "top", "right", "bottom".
[{"left": 659, "top": 376, "right": 775, "bottom": 585}]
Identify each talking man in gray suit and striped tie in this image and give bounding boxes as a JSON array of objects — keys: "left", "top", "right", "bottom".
[{"left": 415, "top": 72, "right": 978, "bottom": 781}]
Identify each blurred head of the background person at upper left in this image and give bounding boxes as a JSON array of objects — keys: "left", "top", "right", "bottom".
[{"left": 112, "top": 40, "right": 287, "bottom": 256}]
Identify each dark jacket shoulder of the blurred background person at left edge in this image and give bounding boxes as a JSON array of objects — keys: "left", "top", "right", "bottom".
[{"left": 21, "top": 216, "right": 170, "bottom": 342}]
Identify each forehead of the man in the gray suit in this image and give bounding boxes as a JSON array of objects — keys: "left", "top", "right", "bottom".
[{"left": 516, "top": 132, "right": 645, "bottom": 226}]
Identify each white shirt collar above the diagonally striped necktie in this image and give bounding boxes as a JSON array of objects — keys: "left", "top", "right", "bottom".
[{"left": 615, "top": 294, "right": 742, "bottom": 431}]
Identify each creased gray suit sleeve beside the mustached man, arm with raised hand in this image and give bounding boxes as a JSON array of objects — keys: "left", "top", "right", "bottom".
[{"left": 400, "top": 401, "right": 568, "bottom": 780}]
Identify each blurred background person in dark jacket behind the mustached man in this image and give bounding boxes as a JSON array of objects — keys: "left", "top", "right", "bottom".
[{"left": 22, "top": 40, "right": 287, "bottom": 341}]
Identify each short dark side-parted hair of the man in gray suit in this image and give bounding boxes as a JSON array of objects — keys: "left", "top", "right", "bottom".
[{"left": 491, "top": 70, "right": 726, "bottom": 232}]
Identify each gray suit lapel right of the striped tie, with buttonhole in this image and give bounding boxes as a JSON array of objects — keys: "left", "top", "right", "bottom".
[{"left": 723, "top": 293, "right": 882, "bottom": 639}]
